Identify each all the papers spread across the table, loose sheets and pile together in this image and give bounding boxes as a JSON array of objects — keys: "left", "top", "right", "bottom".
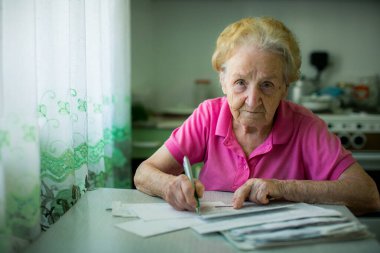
[{"left": 112, "top": 202, "right": 371, "bottom": 250}]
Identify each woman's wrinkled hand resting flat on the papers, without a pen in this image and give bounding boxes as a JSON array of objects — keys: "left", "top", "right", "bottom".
[{"left": 232, "top": 178, "right": 283, "bottom": 209}]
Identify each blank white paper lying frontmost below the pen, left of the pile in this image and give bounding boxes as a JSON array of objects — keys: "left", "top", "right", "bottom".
[{"left": 115, "top": 218, "right": 203, "bottom": 237}]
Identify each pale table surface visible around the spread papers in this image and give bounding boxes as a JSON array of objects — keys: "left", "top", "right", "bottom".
[{"left": 21, "top": 188, "right": 380, "bottom": 253}]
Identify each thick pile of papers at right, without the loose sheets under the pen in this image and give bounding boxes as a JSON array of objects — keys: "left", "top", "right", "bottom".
[{"left": 193, "top": 204, "right": 371, "bottom": 250}]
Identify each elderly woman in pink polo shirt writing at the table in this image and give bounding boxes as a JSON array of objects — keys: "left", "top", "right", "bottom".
[{"left": 134, "top": 18, "right": 380, "bottom": 214}]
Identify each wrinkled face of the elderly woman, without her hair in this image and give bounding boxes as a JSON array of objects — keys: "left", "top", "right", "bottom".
[{"left": 220, "top": 46, "right": 287, "bottom": 128}]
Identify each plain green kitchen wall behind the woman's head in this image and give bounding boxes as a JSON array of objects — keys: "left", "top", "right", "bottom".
[{"left": 131, "top": 0, "right": 380, "bottom": 110}]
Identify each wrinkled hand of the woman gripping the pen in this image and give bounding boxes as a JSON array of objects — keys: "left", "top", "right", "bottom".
[{"left": 164, "top": 174, "right": 204, "bottom": 211}]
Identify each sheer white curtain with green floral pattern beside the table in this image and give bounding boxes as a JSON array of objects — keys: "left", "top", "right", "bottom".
[{"left": 0, "top": 0, "right": 131, "bottom": 252}]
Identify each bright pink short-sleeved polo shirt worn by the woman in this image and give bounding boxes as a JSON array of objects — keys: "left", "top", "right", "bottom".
[{"left": 165, "top": 97, "right": 355, "bottom": 191}]
